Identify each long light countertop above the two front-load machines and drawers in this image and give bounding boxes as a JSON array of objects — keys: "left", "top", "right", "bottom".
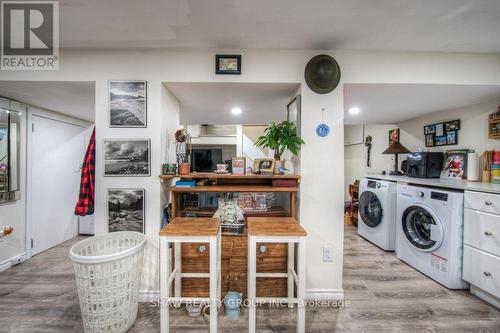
[{"left": 365, "top": 174, "right": 500, "bottom": 194}]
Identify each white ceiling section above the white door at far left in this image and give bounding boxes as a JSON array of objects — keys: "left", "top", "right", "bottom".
[{"left": 0, "top": 81, "right": 95, "bottom": 122}]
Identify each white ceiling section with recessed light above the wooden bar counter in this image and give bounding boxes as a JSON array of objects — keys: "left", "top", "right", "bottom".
[{"left": 164, "top": 82, "right": 299, "bottom": 125}]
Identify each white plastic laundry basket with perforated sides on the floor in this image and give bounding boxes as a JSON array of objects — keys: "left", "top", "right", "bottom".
[{"left": 69, "top": 231, "right": 146, "bottom": 333}]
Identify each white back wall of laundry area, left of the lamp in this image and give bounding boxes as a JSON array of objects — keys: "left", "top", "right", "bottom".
[{"left": 344, "top": 125, "right": 397, "bottom": 201}]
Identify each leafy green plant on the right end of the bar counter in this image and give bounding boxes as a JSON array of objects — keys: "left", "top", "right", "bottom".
[{"left": 255, "top": 121, "right": 305, "bottom": 173}]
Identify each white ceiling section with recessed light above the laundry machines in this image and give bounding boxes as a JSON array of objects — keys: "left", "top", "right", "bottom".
[{"left": 344, "top": 84, "right": 500, "bottom": 124}]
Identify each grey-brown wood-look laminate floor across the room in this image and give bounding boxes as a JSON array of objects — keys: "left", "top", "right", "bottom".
[{"left": 0, "top": 227, "right": 500, "bottom": 333}]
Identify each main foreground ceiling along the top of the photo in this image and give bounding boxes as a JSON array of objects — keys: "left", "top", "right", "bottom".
[{"left": 59, "top": 0, "right": 500, "bottom": 52}]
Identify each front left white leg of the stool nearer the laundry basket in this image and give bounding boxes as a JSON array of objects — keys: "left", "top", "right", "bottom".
[{"left": 160, "top": 237, "right": 170, "bottom": 333}]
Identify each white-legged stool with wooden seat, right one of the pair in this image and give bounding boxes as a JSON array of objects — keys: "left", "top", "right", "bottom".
[{"left": 248, "top": 217, "right": 307, "bottom": 333}]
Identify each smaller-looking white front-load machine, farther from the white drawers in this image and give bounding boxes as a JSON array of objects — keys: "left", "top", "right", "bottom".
[{"left": 358, "top": 178, "right": 397, "bottom": 251}]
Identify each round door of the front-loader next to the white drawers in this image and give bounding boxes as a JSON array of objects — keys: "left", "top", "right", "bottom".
[{"left": 402, "top": 205, "right": 443, "bottom": 252}]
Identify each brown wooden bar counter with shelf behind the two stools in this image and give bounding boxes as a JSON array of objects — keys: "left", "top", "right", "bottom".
[{"left": 160, "top": 173, "right": 300, "bottom": 297}]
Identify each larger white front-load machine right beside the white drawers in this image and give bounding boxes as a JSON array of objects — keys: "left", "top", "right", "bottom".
[{"left": 396, "top": 184, "right": 469, "bottom": 289}]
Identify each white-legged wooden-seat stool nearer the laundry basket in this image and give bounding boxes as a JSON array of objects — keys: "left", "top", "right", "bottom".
[{"left": 160, "top": 217, "right": 221, "bottom": 333}]
